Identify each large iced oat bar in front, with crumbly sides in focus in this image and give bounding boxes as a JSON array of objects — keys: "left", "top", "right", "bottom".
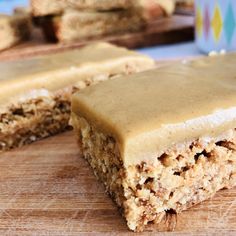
[{"left": 72, "top": 54, "right": 236, "bottom": 231}]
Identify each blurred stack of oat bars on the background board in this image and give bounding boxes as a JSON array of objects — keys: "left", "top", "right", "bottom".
[{"left": 31, "top": 0, "right": 174, "bottom": 43}]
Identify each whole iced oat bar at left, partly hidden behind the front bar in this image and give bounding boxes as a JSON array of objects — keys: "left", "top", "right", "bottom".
[{"left": 0, "top": 43, "right": 155, "bottom": 151}]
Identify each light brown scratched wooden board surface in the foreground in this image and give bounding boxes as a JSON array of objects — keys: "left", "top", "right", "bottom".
[{"left": 0, "top": 131, "right": 236, "bottom": 236}]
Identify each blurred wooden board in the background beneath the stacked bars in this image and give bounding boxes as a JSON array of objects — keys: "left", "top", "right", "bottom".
[{"left": 0, "top": 15, "right": 194, "bottom": 61}]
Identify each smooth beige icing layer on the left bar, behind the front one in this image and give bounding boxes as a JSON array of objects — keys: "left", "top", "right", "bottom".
[{"left": 0, "top": 43, "right": 154, "bottom": 108}]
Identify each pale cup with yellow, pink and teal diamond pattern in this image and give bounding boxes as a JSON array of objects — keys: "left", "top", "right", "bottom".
[{"left": 195, "top": 0, "right": 236, "bottom": 53}]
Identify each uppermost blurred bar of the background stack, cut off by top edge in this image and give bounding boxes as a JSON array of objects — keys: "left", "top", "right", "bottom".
[{"left": 31, "top": 0, "right": 135, "bottom": 16}]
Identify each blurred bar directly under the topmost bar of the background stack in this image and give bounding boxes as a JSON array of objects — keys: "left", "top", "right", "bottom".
[{"left": 41, "top": 10, "right": 145, "bottom": 43}]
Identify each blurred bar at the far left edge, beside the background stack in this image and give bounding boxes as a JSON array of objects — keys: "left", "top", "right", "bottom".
[{"left": 0, "top": 14, "right": 31, "bottom": 51}]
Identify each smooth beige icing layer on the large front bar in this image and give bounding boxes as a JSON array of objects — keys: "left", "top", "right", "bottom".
[{"left": 72, "top": 54, "right": 236, "bottom": 165}]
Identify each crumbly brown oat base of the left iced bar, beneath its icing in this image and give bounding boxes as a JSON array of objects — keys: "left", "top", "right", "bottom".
[{"left": 0, "top": 93, "right": 70, "bottom": 151}]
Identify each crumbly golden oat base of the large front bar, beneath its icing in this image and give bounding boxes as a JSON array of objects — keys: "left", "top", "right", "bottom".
[{"left": 72, "top": 116, "right": 236, "bottom": 231}]
